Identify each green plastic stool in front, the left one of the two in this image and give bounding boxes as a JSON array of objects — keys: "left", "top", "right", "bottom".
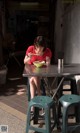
[{"left": 26, "top": 96, "right": 56, "bottom": 133}]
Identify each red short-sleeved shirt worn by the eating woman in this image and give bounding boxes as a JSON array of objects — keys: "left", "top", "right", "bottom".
[{"left": 26, "top": 45, "right": 52, "bottom": 64}]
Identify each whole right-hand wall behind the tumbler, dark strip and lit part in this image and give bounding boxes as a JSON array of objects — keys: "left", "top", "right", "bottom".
[{"left": 54, "top": 0, "right": 80, "bottom": 63}]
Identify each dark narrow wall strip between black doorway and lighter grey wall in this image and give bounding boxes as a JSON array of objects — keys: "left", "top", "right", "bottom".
[{"left": 53, "top": 0, "right": 63, "bottom": 62}]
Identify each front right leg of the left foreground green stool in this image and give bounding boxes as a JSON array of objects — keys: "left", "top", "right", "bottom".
[{"left": 45, "top": 107, "right": 51, "bottom": 133}]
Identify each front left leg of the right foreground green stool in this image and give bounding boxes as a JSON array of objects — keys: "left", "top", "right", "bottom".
[{"left": 62, "top": 107, "right": 68, "bottom": 133}]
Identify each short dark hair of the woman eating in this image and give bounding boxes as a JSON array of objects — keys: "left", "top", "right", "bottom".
[{"left": 34, "top": 36, "right": 47, "bottom": 49}]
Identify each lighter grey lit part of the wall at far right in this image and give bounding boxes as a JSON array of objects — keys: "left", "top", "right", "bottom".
[{"left": 62, "top": 3, "right": 80, "bottom": 63}]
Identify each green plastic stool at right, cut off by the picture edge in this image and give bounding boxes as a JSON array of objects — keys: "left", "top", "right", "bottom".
[{"left": 59, "top": 94, "right": 80, "bottom": 133}]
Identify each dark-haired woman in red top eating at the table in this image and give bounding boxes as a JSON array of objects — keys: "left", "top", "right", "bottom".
[{"left": 24, "top": 36, "right": 52, "bottom": 111}]
